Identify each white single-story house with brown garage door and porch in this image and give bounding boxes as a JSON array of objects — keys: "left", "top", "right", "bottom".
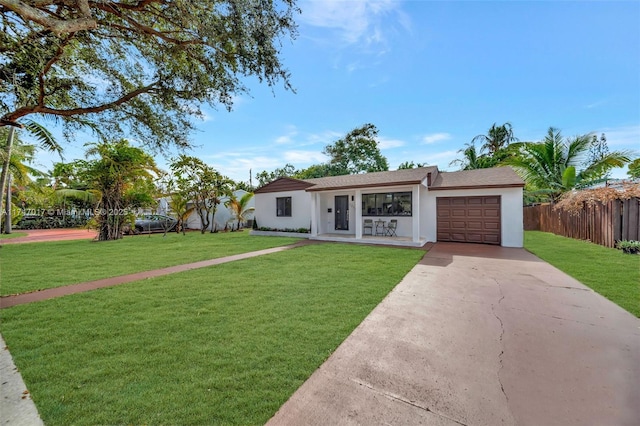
[{"left": 255, "top": 166, "right": 524, "bottom": 247}]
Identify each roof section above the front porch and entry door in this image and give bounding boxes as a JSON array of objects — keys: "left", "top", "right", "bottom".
[{"left": 305, "top": 166, "right": 438, "bottom": 191}]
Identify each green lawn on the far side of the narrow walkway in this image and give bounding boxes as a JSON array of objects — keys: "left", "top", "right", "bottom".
[{"left": 0, "top": 231, "right": 300, "bottom": 295}]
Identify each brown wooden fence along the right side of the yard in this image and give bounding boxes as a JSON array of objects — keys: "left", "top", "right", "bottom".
[{"left": 524, "top": 198, "right": 640, "bottom": 247}]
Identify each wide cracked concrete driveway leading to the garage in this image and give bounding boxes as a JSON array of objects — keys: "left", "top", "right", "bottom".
[{"left": 269, "top": 243, "right": 640, "bottom": 425}]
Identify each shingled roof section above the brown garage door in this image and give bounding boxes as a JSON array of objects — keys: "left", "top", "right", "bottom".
[{"left": 429, "top": 167, "right": 524, "bottom": 191}]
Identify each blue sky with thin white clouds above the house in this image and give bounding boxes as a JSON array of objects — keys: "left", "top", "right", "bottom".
[{"left": 33, "top": 0, "right": 640, "bottom": 183}]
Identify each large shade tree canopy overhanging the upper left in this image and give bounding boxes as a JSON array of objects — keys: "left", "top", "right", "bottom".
[{"left": 0, "top": 0, "right": 298, "bottom": 148}]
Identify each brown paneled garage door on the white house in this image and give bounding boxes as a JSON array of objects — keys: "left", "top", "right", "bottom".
[{"left": 436, "top": 195, "right": 500, "bottom": 244}]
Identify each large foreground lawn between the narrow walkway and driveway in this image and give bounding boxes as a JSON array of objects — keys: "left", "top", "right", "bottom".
[{"left": 0, "top": 244, "right": 424, "bottom": 425}]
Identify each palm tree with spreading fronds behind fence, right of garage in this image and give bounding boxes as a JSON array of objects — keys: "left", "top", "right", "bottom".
[{"left": 504, "top": 127, "right": 629, "bottom": 202}]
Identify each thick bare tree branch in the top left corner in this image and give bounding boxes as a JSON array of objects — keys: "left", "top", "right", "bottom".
[{"left": 0, "top": 0, "right": 98, "bottom": 34}]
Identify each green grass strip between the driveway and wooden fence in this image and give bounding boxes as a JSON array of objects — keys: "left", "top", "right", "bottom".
[{"left": 524, "top": 231, "right": 640, "bottom": 317}]
